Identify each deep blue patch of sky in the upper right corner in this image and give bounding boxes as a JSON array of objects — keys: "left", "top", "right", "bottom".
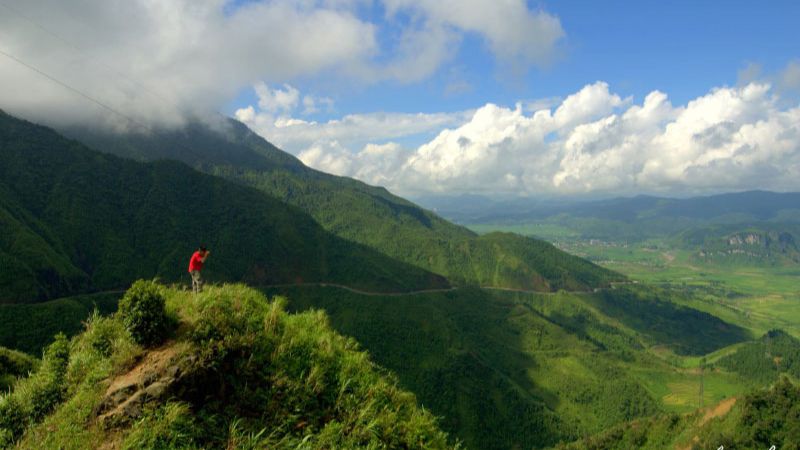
[{"left": 531, "top": 0, "right": 800, "bottom": 103}]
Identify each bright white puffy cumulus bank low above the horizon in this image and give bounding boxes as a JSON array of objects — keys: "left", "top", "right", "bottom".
[{"left": 267, "top": 82, "right": 800, "bottom": 195}]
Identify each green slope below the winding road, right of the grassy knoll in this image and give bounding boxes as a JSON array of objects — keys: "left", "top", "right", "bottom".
[{"left": 267, "top": 287, "right": 749, "bottom": 448}]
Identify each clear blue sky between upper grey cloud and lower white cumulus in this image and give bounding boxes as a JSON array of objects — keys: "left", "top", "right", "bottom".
[{"left": 224, "top": 0, "right": 800, "bottom": 118}]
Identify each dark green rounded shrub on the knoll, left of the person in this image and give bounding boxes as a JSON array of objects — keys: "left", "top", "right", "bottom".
[{"left": 118, "top": 280, "right": 169, "bottom": 347}]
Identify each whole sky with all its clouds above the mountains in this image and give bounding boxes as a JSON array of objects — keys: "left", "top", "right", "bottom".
[{"left": 0, "top": 0, "right": 800, "bottom": 197}]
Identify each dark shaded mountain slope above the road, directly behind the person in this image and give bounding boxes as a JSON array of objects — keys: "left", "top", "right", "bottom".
[{"left": 0, "top": 112, "right": 447, "bottom": 302}]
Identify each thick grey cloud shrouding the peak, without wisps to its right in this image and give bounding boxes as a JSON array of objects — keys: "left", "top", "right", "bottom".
[{"left": 0, "top": 0, "right": 378, "bottom": 125}]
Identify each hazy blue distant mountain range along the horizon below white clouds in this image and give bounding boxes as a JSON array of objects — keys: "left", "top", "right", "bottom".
[{"left": 428, "top": 191, "right": 800, "bottom": 242}]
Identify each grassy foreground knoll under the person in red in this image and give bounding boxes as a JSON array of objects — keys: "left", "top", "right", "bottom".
[{"left": 0, "top": 282, "right": 453, "bottom": 449}]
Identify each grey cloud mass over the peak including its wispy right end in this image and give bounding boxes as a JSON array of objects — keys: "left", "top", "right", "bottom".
[{"left": 0, "top": 0, "right": 563, "bottom": 128}]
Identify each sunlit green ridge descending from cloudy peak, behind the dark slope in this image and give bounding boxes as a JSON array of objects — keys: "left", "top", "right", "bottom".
[{"left": 63, "top": 119, "right": 622, "bottom": 290}]
